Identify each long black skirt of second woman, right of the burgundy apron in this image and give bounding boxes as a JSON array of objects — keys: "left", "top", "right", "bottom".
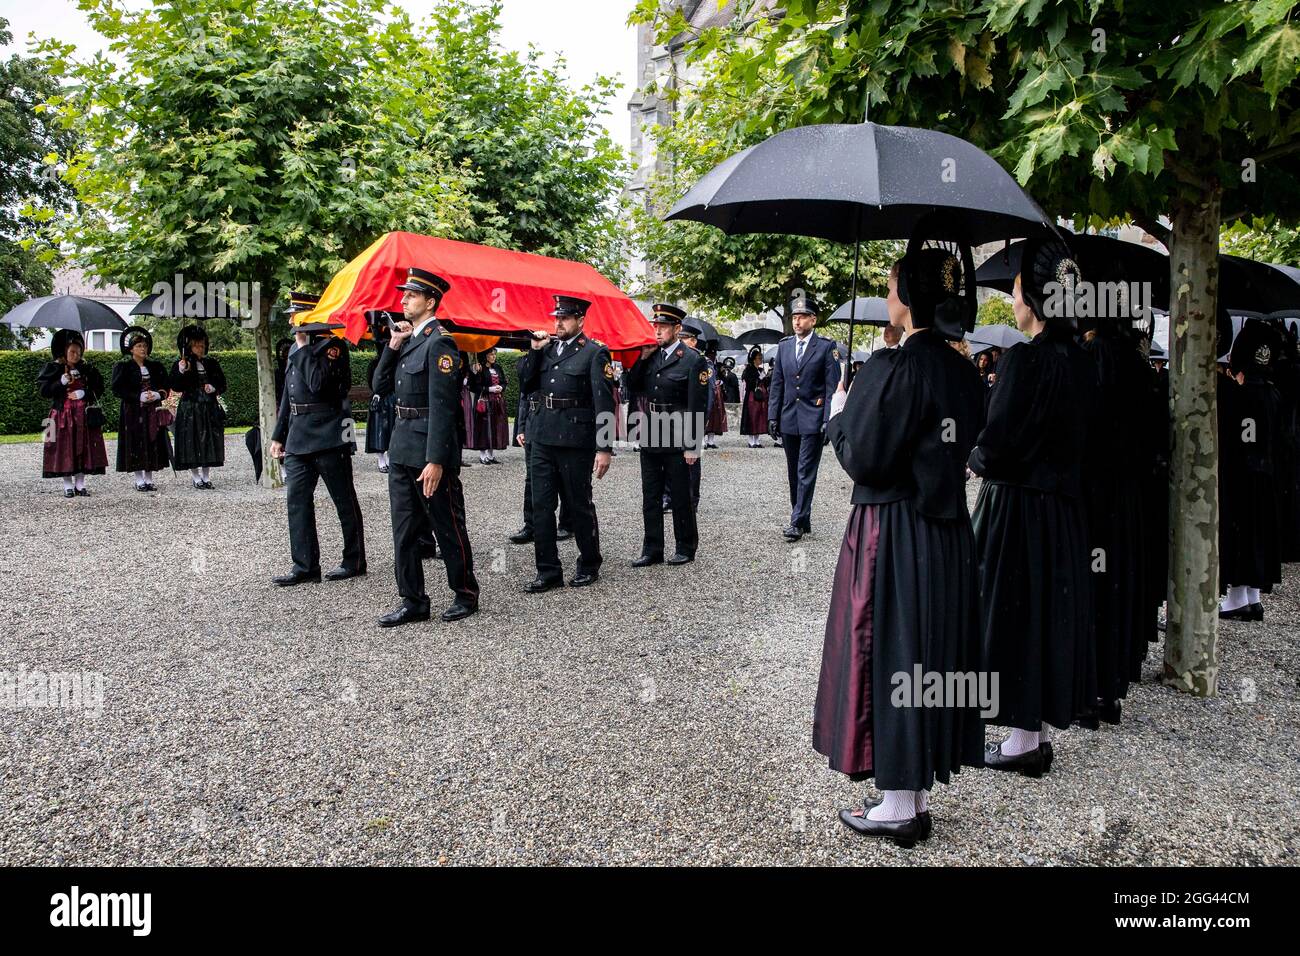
[{"left": 974, "top": 481, "right": 1097, "bottom": 731}]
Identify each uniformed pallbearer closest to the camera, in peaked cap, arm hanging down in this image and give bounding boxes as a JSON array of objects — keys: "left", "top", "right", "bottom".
[{"left": 374, "top": 267, "right": 478, "bottom": 627}]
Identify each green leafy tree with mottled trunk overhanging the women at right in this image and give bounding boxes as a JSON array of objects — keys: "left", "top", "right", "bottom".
[{"left": 642, "top": 0, "right": 1300, "bottom": 695}]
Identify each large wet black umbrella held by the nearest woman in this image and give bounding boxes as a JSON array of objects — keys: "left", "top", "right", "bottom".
[{"left": 667, "top": 122, "right": 1053, "bottom": 382}]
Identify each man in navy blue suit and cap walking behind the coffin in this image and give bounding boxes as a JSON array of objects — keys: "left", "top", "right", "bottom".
[{"left": 767, "top": 295, "right": 840, "bottom": 541}]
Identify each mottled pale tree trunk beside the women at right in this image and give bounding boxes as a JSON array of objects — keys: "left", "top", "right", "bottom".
[{"left": 1164, "top": 183, "right": 1222, "bottom": 697}]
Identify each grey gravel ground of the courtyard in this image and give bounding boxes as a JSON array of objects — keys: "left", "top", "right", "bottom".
[{"left": 0, "top": 433, "right": 1300, "bottom": 865}]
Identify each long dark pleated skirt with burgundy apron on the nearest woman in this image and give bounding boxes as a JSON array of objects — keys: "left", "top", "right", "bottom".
[{"left": 813, "top": 501, "right": 984, "bottom": 790}]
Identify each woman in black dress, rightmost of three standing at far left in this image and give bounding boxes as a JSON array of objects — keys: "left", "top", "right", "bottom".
[{"left": 169, "top": 325, "right": 226, "bottom": 490}]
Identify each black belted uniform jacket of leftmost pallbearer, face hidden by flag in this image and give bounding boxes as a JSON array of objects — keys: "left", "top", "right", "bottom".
[{"left": 270, "top": 337, "right": 352, "bottom": 455}]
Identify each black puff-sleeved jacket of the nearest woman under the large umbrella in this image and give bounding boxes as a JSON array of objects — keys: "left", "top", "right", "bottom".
[{"left": 827, "top": 329, "right": 984, "bottom": 520}]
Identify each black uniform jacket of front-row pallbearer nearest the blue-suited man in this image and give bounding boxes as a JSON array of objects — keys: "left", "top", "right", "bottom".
[{"left": 628, "top": 342, "right": 710, "bottom": 453}]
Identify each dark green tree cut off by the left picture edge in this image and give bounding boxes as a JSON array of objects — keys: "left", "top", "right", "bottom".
[{"left": 0, "top": 17, "right": 74, "bottom": 349}]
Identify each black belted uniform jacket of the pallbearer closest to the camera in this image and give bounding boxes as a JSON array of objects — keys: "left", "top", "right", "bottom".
[{"left": 374, "top": 321, "right": 463, "bottom": 471}]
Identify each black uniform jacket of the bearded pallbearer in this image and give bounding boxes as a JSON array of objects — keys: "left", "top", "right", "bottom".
[{"left": 519, "top": 334, "right": 614, "bottom": 451}]
